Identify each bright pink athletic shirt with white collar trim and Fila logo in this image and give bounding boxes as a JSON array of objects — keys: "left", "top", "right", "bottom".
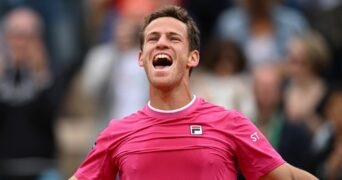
[{"left": 75, "top": 97, "right": 284, "bottom": 180}]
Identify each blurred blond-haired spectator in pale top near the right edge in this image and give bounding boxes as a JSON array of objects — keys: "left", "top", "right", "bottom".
[{"left": 284, "top": 32, "right": 330, "bottom": 132}]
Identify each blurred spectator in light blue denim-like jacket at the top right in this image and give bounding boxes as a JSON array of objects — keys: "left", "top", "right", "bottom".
[{"left": 216, "top": 0, "right": 307, "bottom": 69}]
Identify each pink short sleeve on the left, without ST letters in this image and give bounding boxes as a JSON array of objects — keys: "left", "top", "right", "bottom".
[{"left": 75, "top": 133, "right": 117, "bottom": 180}]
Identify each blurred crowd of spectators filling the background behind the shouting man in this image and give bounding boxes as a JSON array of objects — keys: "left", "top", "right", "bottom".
[{"left": 0, "top": 0, "right": 342, "bottom": 180}]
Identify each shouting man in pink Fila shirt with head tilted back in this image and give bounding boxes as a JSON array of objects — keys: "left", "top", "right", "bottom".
[{"left": 71, "top": 6, "right": 315, "bottom": 180}]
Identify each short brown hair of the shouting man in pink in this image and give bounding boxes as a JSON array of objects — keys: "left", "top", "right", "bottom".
[{"left": 139, "top": 5, "right": 200, "bottom": 51}]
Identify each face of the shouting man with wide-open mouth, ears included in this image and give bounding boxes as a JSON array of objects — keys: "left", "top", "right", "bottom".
[{"left": 139, "top": 17, "right": 199, "bottom": 88}]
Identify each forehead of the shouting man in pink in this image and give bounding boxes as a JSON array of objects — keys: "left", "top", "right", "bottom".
[{"left": 145, "top": 17, "right": 187, "bottom": 37}]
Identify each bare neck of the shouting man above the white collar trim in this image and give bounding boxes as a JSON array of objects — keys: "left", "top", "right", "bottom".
[{"left": 150, "top": 80, "right": 193, "bottom": 110}]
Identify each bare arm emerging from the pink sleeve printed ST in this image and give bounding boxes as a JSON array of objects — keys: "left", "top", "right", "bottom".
[{"left": 260, "top": 163, "right": 318, "bottom": 180}]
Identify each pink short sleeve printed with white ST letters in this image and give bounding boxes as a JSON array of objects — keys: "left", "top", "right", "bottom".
[{"left": 233, "top": 112, "right": 285, "bottom": 179}]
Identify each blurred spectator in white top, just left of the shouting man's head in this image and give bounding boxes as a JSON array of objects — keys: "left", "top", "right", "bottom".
[{"left": 81, "top": 17, "right": 148, "bottom": 125}]
